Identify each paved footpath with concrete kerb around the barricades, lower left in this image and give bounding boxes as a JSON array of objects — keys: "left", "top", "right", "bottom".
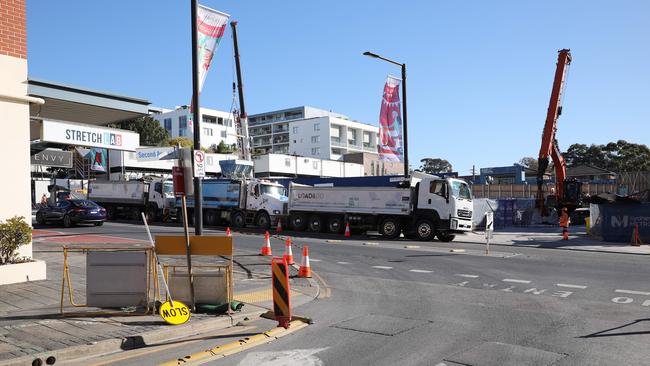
[{"left": 0, "top": 238, "right": 318, "bottom": 365}]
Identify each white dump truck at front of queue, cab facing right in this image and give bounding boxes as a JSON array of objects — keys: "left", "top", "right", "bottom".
[{"left": 289, "top": 172, "right": 472, "bottom": 242}]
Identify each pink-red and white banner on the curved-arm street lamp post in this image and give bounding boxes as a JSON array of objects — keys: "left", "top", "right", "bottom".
[{"left": 379, "top": 75, "right": 404, "bottom": 162}]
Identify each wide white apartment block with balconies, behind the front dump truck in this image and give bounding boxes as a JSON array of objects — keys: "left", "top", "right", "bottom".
[{"left": 248, "top": 106, "right": 379, "bottom": 160}]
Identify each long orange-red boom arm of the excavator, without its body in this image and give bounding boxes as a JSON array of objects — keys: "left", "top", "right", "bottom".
[{"left": 537, "top": 48, "right": 571, "bottom": 213}]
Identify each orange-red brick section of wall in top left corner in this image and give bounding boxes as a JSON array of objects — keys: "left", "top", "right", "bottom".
[{"left": 0, "top": 0, "right": 27, "bottom": 59}]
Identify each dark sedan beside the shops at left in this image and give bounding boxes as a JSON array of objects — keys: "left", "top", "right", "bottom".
[{"left": 36, "top": 199, "right": 106, "bottom": 227}]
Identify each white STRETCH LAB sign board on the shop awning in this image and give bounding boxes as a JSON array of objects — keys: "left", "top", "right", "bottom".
[{"left": 41, "top": 120, "right": 140, "bottom": 151}]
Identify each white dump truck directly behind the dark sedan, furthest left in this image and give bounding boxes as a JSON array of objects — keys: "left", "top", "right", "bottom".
[{"left": 88, "top": 177, "right": 175, "bottom": 221}]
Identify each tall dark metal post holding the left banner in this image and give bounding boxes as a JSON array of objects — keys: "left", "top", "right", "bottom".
[{"left": 190, "top": 0, "right": 203, "bottom": 234}]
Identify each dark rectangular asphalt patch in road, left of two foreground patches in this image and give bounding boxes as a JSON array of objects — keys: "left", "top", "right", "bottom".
[{"left": 332, "top": 314, "right": 430, "bottom": 337}]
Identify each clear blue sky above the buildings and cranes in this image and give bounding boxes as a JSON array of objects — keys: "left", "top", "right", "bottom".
[{"left": 27, "top": 0, "right": 650, "bottom": 174}]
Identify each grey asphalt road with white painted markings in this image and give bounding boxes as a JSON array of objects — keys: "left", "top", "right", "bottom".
[{"left": 35, "top": 223, "right": 650, "bottom": 366}]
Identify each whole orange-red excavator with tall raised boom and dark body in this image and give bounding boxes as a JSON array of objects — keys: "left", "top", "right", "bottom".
[{"left": 535, "top": 48, "right": 582, "bottom": 216}]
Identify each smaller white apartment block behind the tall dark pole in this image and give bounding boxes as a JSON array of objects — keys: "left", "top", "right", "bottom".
[{"left": 150, "top": 106, "right": 237, "bottom": 147}]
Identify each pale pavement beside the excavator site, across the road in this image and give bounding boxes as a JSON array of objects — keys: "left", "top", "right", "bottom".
[{"left": 454, "top": 226, "right": 650, "bottom": 255}]
